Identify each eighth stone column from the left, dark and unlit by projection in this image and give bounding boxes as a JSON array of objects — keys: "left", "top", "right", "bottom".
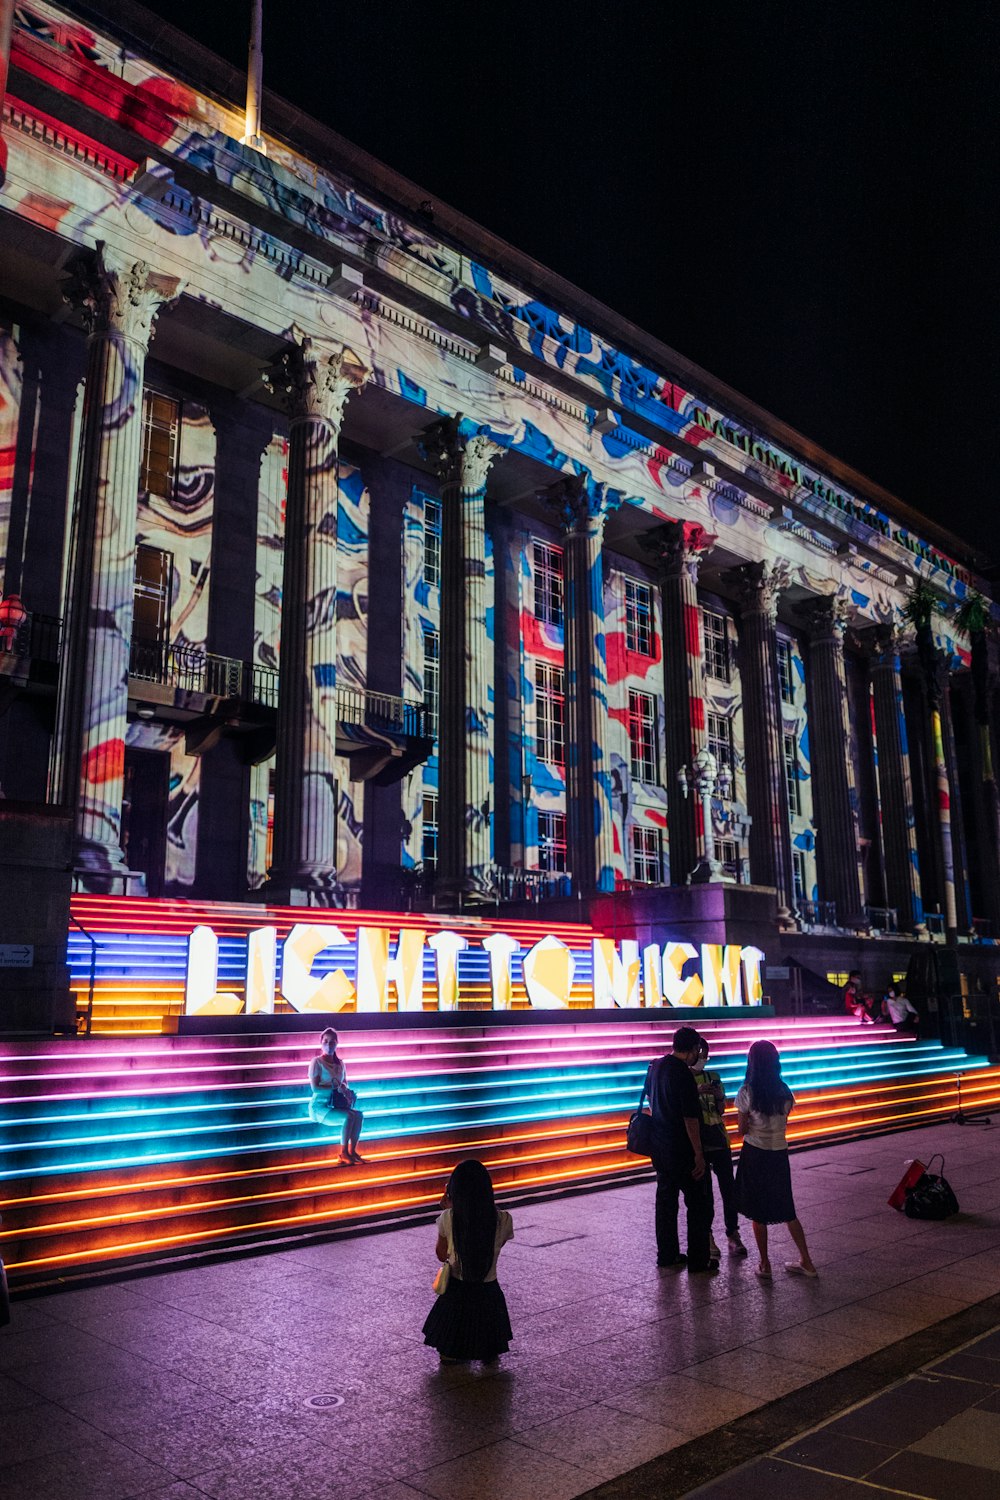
[{"left": 871, "top": 624, "right": 927, "bottom": 935}]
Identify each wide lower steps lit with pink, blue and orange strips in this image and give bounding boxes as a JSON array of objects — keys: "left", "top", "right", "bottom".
[{"left": 0, "top": 1013, "right": 1000, "bottom": 1283}]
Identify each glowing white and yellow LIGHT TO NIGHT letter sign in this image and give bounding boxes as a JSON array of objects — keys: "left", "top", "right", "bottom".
[{"left": 184, "top": 923, "right": 765, "bottom": 1016}]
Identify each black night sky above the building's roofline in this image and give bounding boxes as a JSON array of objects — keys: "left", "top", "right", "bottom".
[{"left": 137, "top": 0, "right": 1000, "bottom": 561}]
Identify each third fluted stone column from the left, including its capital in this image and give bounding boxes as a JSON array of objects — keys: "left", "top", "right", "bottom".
[{"left": 420, "top": 417, "right": 504, "bottom": 902}]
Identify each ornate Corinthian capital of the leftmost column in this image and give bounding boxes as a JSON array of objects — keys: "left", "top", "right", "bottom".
[{"left": 63, "top": 240, "right": 183, "bottom": 348}]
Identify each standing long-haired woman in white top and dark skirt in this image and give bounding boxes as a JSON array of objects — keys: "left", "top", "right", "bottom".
[{"left": 736, "top": 1041, "right": 817, "bottom": 1281}]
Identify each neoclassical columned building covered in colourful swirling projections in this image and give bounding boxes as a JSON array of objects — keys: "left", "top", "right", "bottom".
[{"left": 0, "top": 0, "right": 1000, "bottom": 1020}]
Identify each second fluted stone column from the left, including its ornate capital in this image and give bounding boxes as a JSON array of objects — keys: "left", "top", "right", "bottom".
[{"left": 264, "top": 329, "right": 369, "bottom": 906}]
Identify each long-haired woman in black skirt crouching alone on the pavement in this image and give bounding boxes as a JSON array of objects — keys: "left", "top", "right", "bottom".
[{"left": 423, "top": 1160, "right": 514, "bottom": 1365}]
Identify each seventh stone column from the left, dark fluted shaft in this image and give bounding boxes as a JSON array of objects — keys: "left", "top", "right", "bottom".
[{"left": 804, "top": 596, "right": 868, "bottom": 932}]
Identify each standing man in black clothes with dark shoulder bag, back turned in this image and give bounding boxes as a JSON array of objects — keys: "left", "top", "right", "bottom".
[{"left": 643, "top": 1026, "right": 718, "bottom": 1274}]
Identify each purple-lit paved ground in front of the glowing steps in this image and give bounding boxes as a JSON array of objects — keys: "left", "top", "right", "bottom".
[{"left": 0, "top": 1124, "right": 1000, "bottom": 1500}]
